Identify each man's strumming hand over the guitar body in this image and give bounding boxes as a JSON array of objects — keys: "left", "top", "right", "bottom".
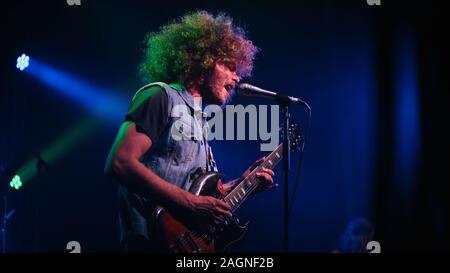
[{"left": 188, "top": 195, "right": 232, "bottom": 224}]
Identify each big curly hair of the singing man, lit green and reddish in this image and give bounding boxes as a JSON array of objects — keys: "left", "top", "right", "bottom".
[{"left": 139, "top": 11, "right": 259, "bottom": 85}]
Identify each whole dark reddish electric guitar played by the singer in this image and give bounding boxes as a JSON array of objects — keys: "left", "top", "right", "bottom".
[{"left": 154, "top": 124, "right": 303, "bottom": 253}]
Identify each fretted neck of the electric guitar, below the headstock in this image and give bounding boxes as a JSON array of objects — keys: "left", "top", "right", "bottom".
[{"left": 224, "top": 144, "right": 283, "bottom": 212}]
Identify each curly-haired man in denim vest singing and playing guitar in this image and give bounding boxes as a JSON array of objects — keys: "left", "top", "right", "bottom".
[{"left": 105, "top": 11, "right": 276, "bottom": 251}]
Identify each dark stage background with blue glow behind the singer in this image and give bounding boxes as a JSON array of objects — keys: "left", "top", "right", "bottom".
[{"left": 0, "top": 0, "right": 450, "bottom": 252}]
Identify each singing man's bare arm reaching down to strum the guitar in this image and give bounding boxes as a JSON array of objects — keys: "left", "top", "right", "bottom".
[{"left": 105, "top": 121, "right": 230, "bottom": 220}]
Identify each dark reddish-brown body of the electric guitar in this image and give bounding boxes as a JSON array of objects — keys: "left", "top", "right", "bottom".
[{"left": 155, "top": 172, "right": 248, "bottom": 253}]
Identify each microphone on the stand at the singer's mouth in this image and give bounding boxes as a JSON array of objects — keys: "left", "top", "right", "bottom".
[{"left": 237, "top": 83, "right": 310, "bottom": 108}]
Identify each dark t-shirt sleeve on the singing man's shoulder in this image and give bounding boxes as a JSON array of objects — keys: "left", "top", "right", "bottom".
[{"left": 125, "top": 86, "right": 169, "bottom": 143}]
